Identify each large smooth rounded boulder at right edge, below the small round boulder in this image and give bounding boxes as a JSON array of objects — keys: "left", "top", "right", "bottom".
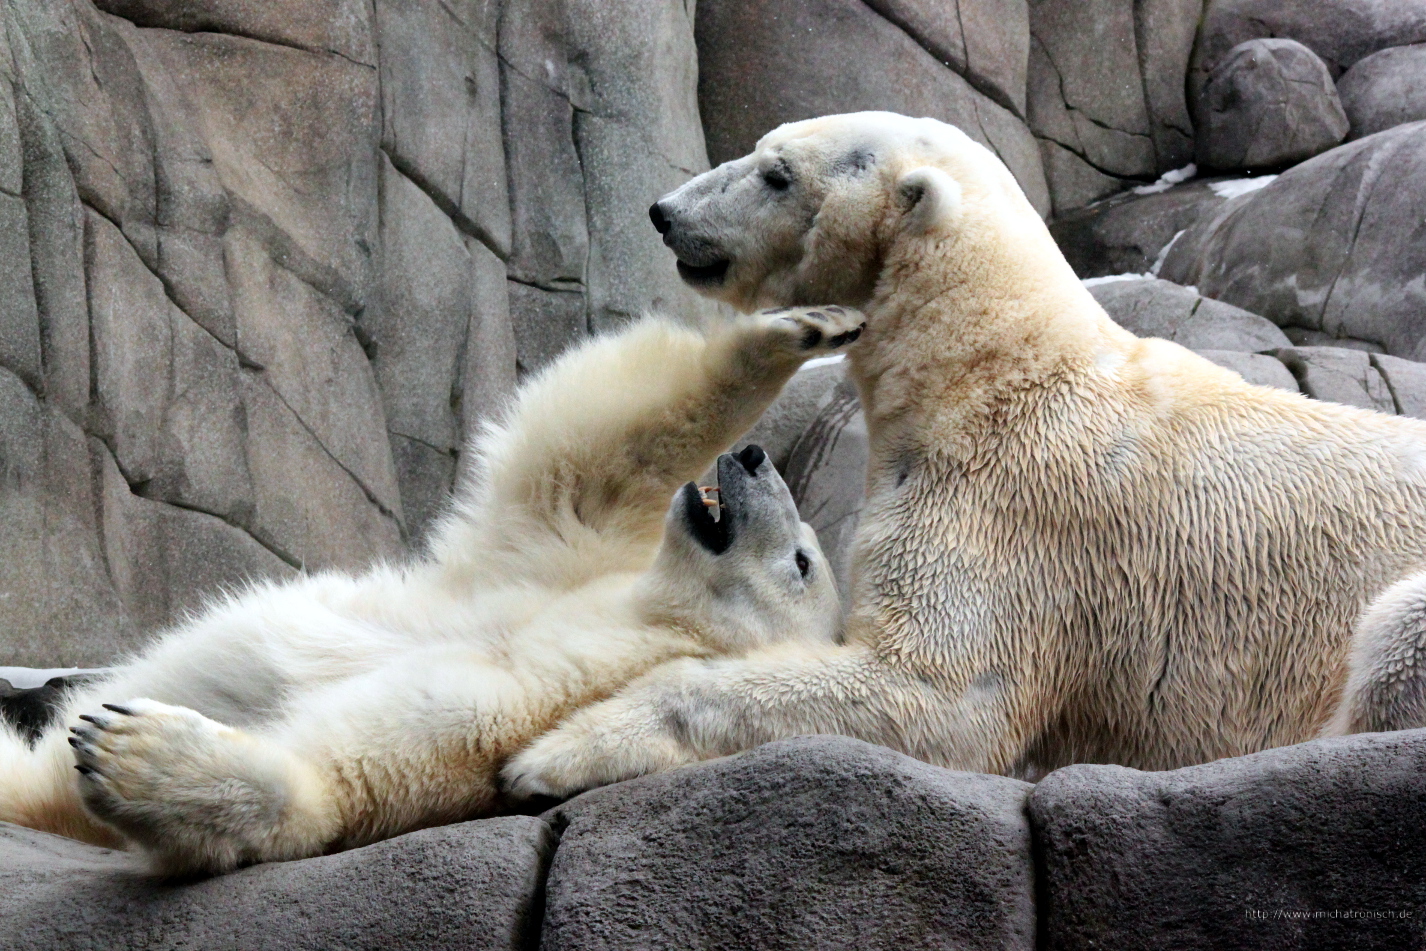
[{"left": 1159, "top": 123, "right": 1426, "bottom": 359}]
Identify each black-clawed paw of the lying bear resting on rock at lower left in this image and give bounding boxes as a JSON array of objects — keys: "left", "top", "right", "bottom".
[{"left": 70, "top": 699, "right": 306, "bottom": 873}]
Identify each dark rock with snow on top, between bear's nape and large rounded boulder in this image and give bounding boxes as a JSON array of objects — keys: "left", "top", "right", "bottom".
[{"left": 1050, "top": 181, "right": 1225, "bottom": 278}]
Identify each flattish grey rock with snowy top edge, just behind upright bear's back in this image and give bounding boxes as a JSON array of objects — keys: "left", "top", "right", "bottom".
[{"left": 1089, "top": 278, "right": 1291, "bottom": 352}]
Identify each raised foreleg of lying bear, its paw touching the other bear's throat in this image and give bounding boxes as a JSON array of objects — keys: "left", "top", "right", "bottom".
[{"left": 432, "top": 307, "right": 864, "bottom": 586}]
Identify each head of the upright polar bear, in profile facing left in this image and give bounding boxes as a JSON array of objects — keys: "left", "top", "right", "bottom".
[{"left": 649, "top": 113, "right": 1042, "bottom": 311}]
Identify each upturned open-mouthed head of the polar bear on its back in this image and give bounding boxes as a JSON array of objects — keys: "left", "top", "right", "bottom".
[{"left": 643, "top": 446, "right": 841, "bottom": 653}]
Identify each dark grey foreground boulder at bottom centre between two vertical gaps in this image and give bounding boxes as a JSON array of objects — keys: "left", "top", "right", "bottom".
[{"left": 540, "top": 737, "right": 1035, "bottom": 951}]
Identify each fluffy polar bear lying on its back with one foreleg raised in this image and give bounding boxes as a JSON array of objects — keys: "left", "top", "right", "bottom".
[{"left": 0, "top": 307, "right": 861, "bottom": 874}]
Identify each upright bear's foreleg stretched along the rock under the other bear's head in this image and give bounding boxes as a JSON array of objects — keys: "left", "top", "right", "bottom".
[{"left": 501, "top": 646, "right": 1020, "bottom": 797}]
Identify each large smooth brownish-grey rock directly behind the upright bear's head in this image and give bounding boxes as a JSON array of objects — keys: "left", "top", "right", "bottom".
[{"left": 696, "top": 0, "right": 1050, "bottom": 214}]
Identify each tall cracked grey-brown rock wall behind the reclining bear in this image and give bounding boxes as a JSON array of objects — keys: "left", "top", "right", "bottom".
[{"left": 0, "top": 0, "right": 713, "bottom": 666}]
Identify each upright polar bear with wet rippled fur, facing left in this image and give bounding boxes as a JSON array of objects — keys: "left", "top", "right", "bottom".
[{"left": 505, "top": 113, "right": 1426, "bottom": 794}]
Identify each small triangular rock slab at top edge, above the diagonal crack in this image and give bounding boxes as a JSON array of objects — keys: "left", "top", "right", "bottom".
[{"left": 867, "top": 0, "right": 1030, "bottom": 115}]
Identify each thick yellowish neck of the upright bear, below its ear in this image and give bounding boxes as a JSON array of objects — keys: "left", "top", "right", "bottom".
[{"left": 850, "top": 210, "right": 1134, "bottom": 453}]
